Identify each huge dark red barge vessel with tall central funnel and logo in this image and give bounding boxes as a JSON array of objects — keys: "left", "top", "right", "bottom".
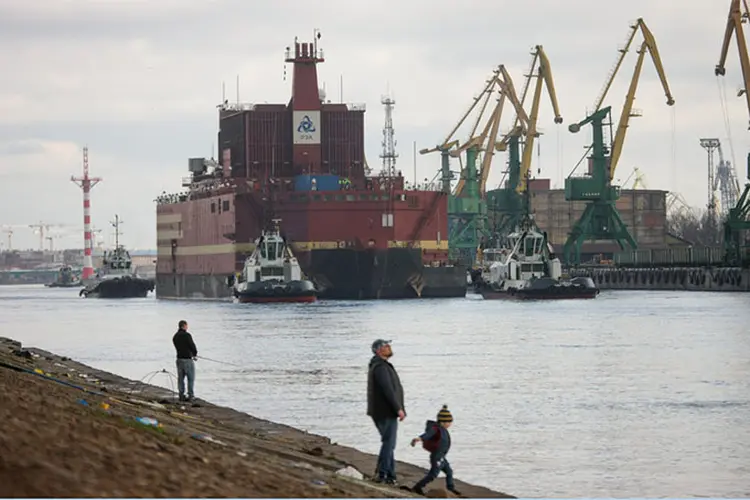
[{"left": 156, "top": 40, "right": 467, "bottom": 299}]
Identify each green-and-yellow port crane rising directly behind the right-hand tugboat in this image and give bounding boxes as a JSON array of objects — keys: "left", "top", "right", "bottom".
[{"left": 487, "top": 45, "right": 563, "bottom": 242}]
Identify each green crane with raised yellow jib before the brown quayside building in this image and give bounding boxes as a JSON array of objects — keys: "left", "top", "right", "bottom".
[{"left": 563, "top": 18, "right": 674, "bottom": 264}]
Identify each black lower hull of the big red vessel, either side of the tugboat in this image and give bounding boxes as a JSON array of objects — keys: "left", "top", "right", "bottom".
[{"left": 156, "top": 248, "right": 466, "bottom": 300}]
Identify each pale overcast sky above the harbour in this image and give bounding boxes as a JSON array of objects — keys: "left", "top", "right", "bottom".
[{"left": 0, "top": 0, "right": 748, "bottom": 248}]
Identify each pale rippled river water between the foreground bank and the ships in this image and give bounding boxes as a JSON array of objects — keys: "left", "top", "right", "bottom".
[{"left": 0, "top": 286, "right": 750, "bottom": 497}]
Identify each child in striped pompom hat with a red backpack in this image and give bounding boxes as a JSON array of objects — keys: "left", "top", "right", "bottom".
[{"left": 411, "top": 405, "right": 461, "bottom": 496}]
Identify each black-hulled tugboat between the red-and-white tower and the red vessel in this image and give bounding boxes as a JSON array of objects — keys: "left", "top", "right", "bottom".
[{"left": 79, "top": 215, "right": 155, "bottom": 299}]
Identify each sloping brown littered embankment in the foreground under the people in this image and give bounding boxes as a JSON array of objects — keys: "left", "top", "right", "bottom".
[{"left": 0, "top": 338, "right": 514, "bottom": 498}]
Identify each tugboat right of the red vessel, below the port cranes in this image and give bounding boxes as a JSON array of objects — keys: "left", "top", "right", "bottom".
[{"left": 472, "top": 190, "right": 599, "bottom": 300}]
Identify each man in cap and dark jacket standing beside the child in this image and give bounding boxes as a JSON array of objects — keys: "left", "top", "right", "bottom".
[{"left": 367, "top": 339, "right": 406, "bottom": 484}]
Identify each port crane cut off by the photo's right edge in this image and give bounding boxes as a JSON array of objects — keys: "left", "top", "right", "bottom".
[{"left": 714, "top": 0, "right": 750, "bottom": 266}]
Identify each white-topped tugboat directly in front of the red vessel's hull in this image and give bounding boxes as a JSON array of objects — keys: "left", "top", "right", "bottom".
[{"left": 227, "top": 219, "right": 318, "bottom": 304}]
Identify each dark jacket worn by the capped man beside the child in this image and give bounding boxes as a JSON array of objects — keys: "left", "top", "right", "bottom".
[{"left": 367, "top": 356, "right": 406, "bottom": 420}]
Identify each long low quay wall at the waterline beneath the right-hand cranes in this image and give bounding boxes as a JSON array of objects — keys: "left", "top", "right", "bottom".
[{"left": 569, "top": 267, "right": 750, "bottom": 292}]
